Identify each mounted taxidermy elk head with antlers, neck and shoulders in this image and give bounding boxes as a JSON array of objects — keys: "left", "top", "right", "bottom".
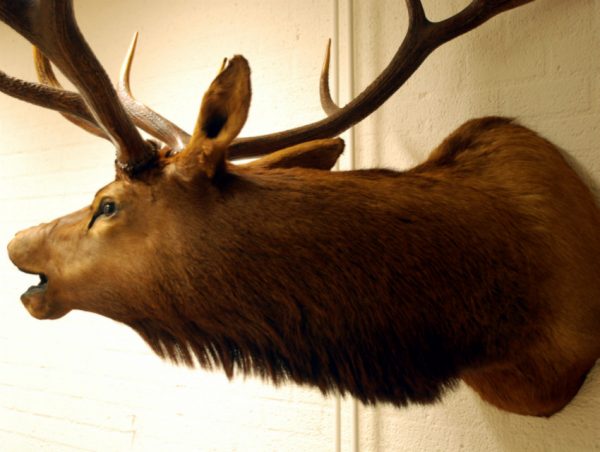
[{"left": 0, "top": 0, "right": 600, "bottom": 415}]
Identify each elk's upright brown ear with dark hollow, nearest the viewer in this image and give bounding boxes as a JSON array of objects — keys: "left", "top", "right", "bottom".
[{"left": 178, "top": 55, "right": 251, "bottom": 179}]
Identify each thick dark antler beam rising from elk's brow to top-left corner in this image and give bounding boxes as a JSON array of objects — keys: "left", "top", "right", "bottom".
[{"left": 0, "top": 0, "right": 157, "bottom": 175}]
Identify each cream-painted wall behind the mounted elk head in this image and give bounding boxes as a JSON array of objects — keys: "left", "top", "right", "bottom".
[{"left": 0, "top": 0, "right": 600, "bottom": 452}]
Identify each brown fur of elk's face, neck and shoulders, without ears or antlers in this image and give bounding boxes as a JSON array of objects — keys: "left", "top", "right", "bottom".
[{"left": 9, "top": 118, "right": 600, "bottom": 415}]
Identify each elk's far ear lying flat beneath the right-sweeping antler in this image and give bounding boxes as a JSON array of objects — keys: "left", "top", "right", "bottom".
[{"left": 240, "top": 138, "right": 344, "bottom": 170}]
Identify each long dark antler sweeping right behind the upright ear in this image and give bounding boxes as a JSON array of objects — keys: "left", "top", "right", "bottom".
[{"left": 229, "top": 0, "right": 533, "bottom": 158}]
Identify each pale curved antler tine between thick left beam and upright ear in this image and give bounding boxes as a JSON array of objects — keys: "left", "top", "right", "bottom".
[{"left": 117, "top": 32, "right": 190, "bottom": 152}]
